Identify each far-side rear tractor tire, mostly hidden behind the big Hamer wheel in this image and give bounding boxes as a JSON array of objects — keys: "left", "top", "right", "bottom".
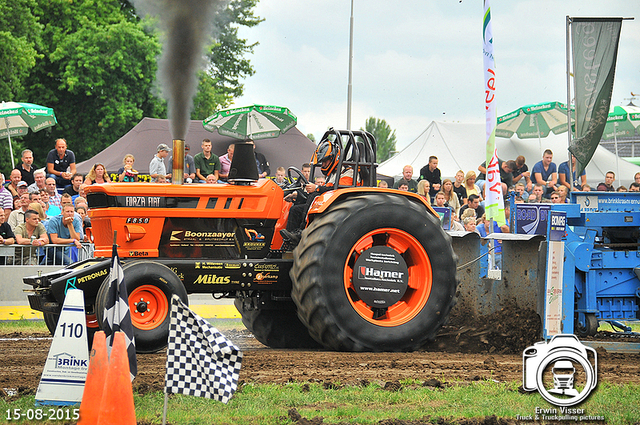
[{"left": 234, "top": 298, "right": 322, "bottom": 349}]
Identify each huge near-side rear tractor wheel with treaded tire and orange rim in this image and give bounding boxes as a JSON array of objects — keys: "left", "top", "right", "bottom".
[{"left": 290, "top": 193, "right": 457, "bottom": 351}]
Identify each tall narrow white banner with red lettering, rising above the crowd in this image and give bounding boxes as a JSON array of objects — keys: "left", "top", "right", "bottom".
[{"left": 482, "top": 0, "right": 506, "bottom": 225}]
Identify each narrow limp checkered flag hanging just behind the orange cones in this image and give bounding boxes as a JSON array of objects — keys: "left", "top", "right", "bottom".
[{"left": 102, "top": 240, "right": 138, "bottom": 381}]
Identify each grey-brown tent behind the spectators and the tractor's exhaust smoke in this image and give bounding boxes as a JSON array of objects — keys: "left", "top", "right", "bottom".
[{"left": 77, "top": 118, "right": 316, "bottom": 175}]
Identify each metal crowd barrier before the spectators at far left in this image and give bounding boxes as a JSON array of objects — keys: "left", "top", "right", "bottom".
[{"left": 0, "top": 242, "right": 94, "bottom": 267}]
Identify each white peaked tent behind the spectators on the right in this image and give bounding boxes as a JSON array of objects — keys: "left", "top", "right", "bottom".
[{"left": 378, "top": 121, "right": 640, "bottom": 187}]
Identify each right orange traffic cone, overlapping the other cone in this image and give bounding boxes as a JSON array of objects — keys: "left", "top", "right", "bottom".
[{"left": 98, "top": 332, "right": 136, "bottom": 425}]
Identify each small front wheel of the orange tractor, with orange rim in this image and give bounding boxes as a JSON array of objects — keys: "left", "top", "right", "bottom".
[{"left": 96, "top": 261, "right": 189, "bottom": 354}]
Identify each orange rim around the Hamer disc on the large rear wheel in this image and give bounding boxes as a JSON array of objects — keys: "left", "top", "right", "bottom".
[{"left": 344, "top": 228, "right": 433, "bottom": 327}]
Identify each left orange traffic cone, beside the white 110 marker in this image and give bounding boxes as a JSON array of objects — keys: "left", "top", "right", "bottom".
[{"left": 78, "top": 331, "right": 109, "bottom": 425}]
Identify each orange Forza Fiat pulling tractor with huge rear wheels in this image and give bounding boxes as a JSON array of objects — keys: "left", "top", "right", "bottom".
[{"left": 24, "top": 129, "right": 457, "bottom": 353}]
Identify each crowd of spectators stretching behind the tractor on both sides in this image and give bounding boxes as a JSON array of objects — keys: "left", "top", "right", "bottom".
[{"left": 0, "top": 134, "right": 640, "bottom": 264}]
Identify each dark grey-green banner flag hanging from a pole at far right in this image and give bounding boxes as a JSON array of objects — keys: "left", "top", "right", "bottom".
[{"left": 569, "top": 18, "right": 622, "bottom": 175}]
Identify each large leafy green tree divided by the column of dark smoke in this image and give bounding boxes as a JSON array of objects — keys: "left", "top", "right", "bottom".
[{"left": 18, "top": 0, "right": 262, "bottom": 166}]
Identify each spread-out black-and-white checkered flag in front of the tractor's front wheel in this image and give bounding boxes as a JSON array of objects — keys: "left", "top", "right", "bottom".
[{"left": 164, "top": 295, "right": 242, "bottom": 403}]
